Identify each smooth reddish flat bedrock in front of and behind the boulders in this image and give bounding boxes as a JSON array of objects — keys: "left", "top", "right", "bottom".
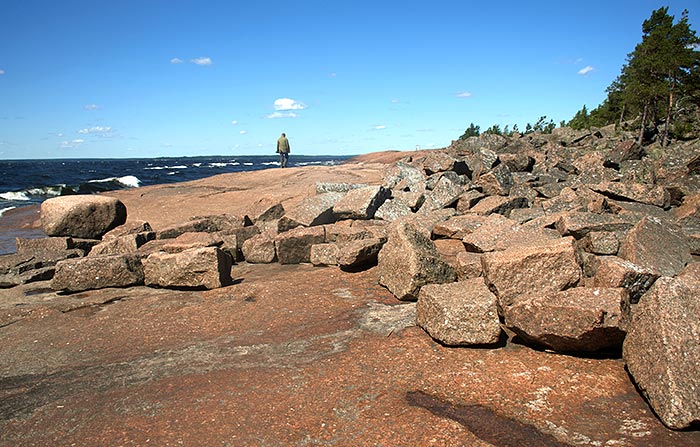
[{"left": 0, "top": 162, "right": 700, "bottom": 447}]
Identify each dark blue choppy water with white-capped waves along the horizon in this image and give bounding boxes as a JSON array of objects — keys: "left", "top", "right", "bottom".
[{"left": 0, "top": 155, "right": 348, "bottom": 216}]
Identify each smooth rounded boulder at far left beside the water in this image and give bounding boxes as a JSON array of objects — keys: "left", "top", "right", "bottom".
[{"left": 41, "top": 195, "right": 126, "bottom": 239}]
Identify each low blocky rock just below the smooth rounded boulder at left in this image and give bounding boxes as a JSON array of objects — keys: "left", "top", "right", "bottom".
[{"left": 51, "top": 255, "right": 144, "bottom": 292}]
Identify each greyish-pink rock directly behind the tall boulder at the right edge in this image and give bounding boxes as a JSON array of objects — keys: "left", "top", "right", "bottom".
[{"left": 619, "top": 217, "right": 693, "bottom": 276}]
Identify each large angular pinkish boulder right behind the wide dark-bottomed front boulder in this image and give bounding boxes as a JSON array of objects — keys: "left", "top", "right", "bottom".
[{"left": 481, "top": 237, "right": 581, "bottom": 309}]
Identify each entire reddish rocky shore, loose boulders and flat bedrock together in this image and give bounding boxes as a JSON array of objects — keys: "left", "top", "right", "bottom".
[{"left": 0, "top": 128, "right": 700, "bottom": 446}]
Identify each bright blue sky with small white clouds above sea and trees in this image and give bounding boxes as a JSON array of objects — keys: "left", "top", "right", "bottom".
[{"left": 0, "top": 0, "right": 700, "bottom": 159}]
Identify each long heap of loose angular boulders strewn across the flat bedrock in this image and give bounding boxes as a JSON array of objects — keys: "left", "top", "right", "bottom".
[{"left": 0, "top": 127, "right": 700, "bottom": 429}]
